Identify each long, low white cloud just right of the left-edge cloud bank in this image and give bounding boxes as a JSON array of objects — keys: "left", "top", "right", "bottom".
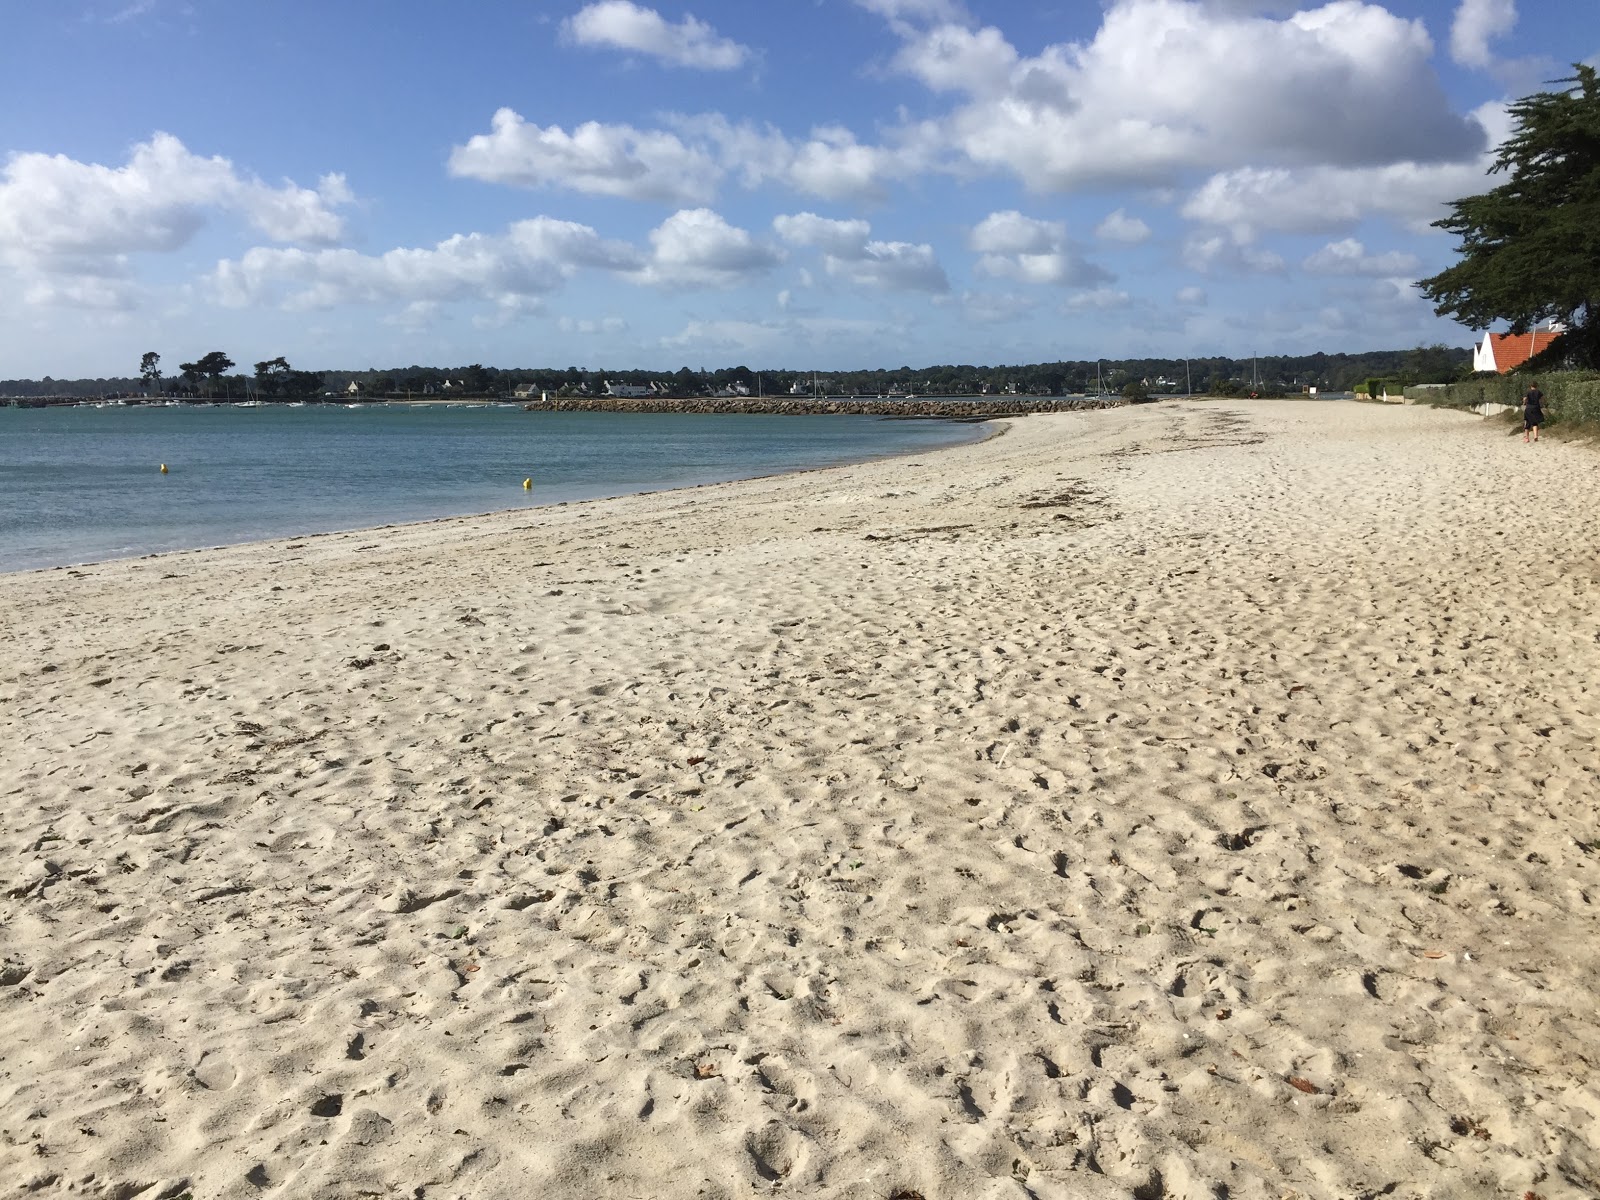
[{"left": 211, "top": 216, "right": 645, "bottom": 309}]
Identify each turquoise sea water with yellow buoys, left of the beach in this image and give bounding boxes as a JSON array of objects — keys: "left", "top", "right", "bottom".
[{"left": 0, "top": 405, "right": 984, "bottom": 571}]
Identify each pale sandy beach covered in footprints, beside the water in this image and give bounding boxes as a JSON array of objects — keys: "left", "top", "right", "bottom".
[{"left": 0, "top": 402, "right": 1600, "bottom": 1200}]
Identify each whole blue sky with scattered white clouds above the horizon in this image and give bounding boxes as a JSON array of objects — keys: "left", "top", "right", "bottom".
[{"left": 0, "top": 0, "right": 1600, "bottom": 378}]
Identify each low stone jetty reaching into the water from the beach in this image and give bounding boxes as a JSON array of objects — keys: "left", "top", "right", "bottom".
[{"left": 523, "top": 395, "right": 1128, "bottom": 421}]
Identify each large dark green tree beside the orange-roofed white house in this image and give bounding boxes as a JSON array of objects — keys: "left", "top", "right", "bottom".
[{"left": 1418, "top": 64, "right": 1600, "bottom": 366}]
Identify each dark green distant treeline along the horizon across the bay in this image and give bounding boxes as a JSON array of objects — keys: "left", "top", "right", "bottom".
[{"left": 0, "top": 346, "right": 1472, "bottom": 398}]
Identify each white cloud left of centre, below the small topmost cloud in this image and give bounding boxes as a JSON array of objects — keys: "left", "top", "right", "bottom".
[{"left": 450, "top": 109, "right": 722, "bottom": 205}]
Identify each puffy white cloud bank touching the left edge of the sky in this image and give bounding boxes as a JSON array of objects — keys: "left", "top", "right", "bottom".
[{"left": 0, "top": 133, "right": 352, "bottom": 309}]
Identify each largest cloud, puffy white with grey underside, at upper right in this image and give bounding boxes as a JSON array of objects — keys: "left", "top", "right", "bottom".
[{"left": 894, "top": 0, "right": 1482, "bottom": 190}]
